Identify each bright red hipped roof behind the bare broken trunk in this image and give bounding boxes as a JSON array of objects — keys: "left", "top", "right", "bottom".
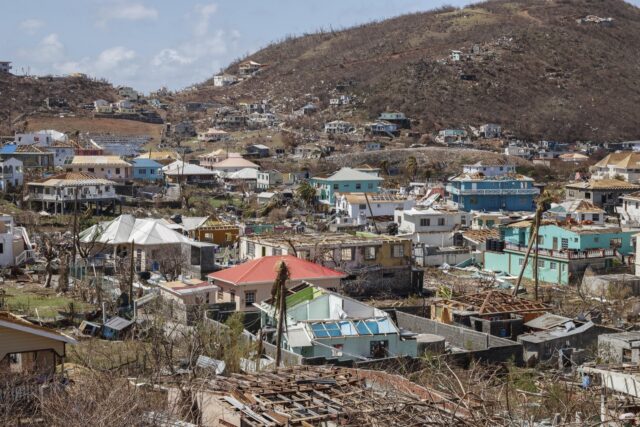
[{"left": 208, "top": 255, "right": 347, "bottom": 286}]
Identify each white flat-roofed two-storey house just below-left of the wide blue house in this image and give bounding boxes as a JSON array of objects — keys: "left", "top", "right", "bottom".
[{"left": 394, "top": 208, "right": 471, "bottom": 246}]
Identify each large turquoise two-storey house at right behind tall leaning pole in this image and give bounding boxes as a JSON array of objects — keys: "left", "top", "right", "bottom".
[{"left": 484, "top": 221, "right": 638, "bottom": 285}]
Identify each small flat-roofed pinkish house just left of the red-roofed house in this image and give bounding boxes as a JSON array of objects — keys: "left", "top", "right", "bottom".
[{"left": 158, "top": 278, "right": 218, "bottom": 324}]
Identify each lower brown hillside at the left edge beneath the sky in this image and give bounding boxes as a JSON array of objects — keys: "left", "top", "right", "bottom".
[{"left": 0, "top": 73, "right": 117, "bottom": 135}]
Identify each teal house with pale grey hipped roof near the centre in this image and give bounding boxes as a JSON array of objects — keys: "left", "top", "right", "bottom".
[{"left": 311, "top": 168, "right": 384, "bottom": 205}]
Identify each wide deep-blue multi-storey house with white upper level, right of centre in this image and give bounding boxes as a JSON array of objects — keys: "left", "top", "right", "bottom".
[{"left": 447, "top": 163, "right": 540, "bottom": 212}]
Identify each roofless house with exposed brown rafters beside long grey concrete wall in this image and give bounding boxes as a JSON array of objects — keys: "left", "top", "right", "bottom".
[{"left": 430, "top": 290, "right": 550, "bottom": 340}]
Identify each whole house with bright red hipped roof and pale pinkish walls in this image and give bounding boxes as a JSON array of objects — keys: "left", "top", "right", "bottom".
[{"left": 207, "top": 255, "right": 346, "bottom": 311}]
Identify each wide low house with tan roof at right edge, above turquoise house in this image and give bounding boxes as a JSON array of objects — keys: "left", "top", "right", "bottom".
[{"left": 564, "top": 178, "right": 640, "bottom": 213}]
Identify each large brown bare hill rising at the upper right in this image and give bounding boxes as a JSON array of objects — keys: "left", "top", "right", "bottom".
[{"left": 195, "top": 0, "right": 640, "bottom": 144}]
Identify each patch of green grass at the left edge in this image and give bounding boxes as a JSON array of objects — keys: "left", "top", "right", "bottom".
[{"left": 1, "top": 285, "right": 93, "bottom": 318}]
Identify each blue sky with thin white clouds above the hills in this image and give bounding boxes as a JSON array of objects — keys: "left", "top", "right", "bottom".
[{"left": 0, "top": 0, "right": 640, "bottom": 92}]
